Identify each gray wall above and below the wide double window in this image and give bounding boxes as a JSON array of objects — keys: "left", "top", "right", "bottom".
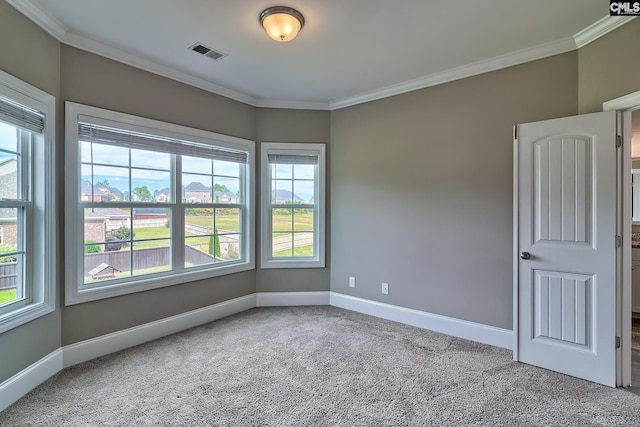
[{"left": 60, "top": 45, "right": 256, "bottom": 345}]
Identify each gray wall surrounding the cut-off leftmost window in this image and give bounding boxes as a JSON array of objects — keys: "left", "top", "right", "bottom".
[{"left": 0, "top": 1, "right": 62, "bottom": 383}]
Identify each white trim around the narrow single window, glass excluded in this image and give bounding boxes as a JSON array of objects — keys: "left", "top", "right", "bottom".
[{"left": 260, "top": 142, "right": 326, "bottom": 268}]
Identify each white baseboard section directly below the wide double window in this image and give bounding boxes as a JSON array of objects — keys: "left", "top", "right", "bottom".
[{"left": 62, "top": 294, "right": 256, "bottom": 368}]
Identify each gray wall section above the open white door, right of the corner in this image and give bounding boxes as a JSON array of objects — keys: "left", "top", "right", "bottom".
[{"left": 578, "top": 19, "right": 640, "bottom": 114}]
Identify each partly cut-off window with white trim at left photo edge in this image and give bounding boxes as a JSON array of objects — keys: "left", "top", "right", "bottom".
[{"left": 0, "top": 72, "right": 56, "bottom": 333}]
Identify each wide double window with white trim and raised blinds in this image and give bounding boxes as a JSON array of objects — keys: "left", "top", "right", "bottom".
[{"left": 66, "top": 103, "right": 254, "bottom": 304}]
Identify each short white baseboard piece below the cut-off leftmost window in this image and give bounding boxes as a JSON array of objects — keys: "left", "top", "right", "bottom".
[{"left": 0, "top": 348, "right": 62, "bottom": 412}]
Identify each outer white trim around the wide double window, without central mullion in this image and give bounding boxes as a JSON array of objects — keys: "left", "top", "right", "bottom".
[{"left": 65, "top": 102, "right": 255, "bottom": 306}]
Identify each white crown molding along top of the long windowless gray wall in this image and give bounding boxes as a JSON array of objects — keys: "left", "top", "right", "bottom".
[{"left": 329, "top": 37, "right": 576, "bottom": 110}]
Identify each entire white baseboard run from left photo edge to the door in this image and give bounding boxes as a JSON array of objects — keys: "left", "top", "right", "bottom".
[{"left": 0, "top": 291, "right": 513, "bottom": 411}]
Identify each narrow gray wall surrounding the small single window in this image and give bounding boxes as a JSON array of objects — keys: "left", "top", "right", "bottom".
[{"left": 256, "top": 108, "right": 331, "bottom": 292}]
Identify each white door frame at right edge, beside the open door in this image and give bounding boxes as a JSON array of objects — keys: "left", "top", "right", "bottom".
[{"left": 602, "top": 91, "right": 640, "bottom": 387}]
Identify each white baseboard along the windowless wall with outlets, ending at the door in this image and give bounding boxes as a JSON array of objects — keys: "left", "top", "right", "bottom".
[{"left": 330, "top": 292, "right": 513, "bottom": 350}]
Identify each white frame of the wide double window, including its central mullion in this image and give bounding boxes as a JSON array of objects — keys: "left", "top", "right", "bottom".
[{"left": 65, "top": 102, "right": 255, "bottom": 306}]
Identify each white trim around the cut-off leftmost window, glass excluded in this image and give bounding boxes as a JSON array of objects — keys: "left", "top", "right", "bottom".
[{"left": 0, "top": 71, "right": 58, "bottom": 333}]
